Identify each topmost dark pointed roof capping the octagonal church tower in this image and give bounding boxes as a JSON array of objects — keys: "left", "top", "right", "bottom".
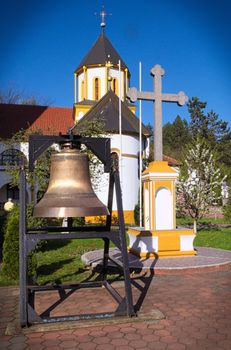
[{"left": 75, "top": 31, "right": 128, "bottom": 73}]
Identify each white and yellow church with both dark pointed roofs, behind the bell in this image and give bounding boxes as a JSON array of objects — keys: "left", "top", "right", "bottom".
[{"left": 72, "top": 22, "right": 149, "bottom": 224}]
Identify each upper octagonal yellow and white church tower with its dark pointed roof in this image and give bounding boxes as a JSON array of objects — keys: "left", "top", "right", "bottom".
[{"left": 74, "top": 27, "right": 135, "bottom": 122}]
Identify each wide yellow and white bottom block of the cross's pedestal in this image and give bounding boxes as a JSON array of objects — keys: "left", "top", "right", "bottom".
[{"left": 128, "top": 227, "right": 197, "bottom": 258}]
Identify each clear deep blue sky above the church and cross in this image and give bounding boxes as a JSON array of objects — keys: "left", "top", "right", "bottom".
[{"left": 0, "top": 0, "right": 231, "bottom": 126}]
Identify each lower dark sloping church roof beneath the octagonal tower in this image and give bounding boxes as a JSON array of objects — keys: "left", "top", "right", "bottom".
[{"left": 73, "top": 90, "right": 150, "bottom": 136}]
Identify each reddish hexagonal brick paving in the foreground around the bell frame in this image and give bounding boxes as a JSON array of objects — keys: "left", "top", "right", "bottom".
[{"left": 0, "top": 268, "right": 231, "bottom": 350}]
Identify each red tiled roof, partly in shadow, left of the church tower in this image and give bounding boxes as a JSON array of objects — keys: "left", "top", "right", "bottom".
[{"left": 0, "top": 104, "right": 74, "bottom": 139}]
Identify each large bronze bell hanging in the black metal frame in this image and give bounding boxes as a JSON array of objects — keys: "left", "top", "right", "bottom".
[{"left": 34, "top": 143, "right": 109, "bottom": 218}]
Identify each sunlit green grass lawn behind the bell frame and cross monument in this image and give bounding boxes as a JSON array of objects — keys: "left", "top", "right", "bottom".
[{"left": 0, "top": 228, "right": 231, "bottom": 285}]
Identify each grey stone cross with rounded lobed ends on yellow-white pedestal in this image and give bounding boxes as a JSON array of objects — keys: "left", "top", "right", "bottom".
[{"left": 127, "top": 64, "right": 188, "bottom": 161}]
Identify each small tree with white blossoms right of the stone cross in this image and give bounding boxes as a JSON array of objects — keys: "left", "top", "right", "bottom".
[{"left": 177, "top": 139, "right": 222, "bottom": 234}]
